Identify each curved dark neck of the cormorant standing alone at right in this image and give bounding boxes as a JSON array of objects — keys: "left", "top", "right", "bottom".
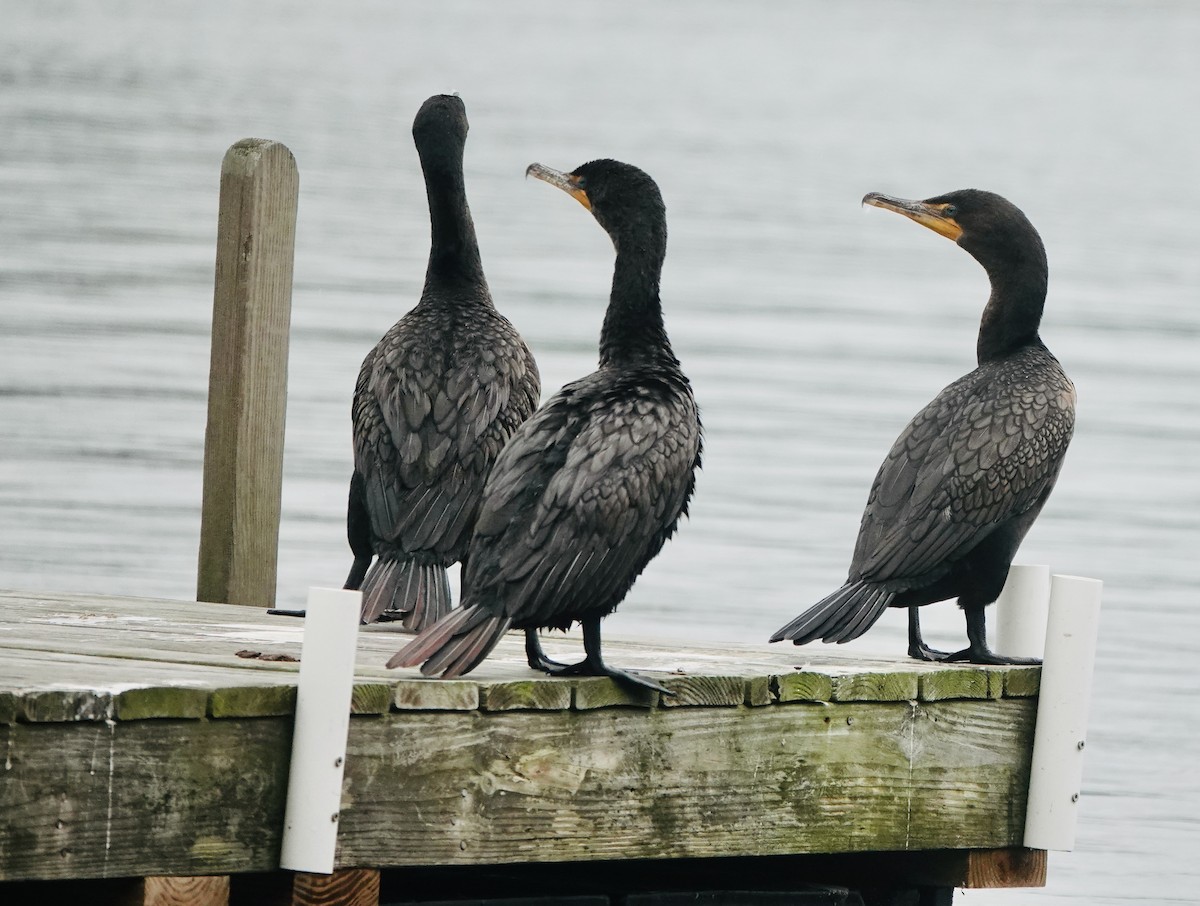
[{"left": 960, "top": 235, "right": 1049, "bottom": 365}]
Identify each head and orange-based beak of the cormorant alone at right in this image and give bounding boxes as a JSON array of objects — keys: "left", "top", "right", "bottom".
[{"left": 863, "top": 188, "right": 1045, "bottom": 272}]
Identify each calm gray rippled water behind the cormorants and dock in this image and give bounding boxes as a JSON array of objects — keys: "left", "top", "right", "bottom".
[{"left": 0, "top": 0, "right": 1200, "bottom": 904}]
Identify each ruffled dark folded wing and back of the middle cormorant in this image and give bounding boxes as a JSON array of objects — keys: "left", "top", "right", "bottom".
[{"left": 463, "top": 372, "right": 701, "bottom": 628}]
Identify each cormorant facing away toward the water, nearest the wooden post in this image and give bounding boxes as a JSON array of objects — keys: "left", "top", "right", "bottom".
[{"left": 346, "top": 95, "right": 541, "bottom": 631}]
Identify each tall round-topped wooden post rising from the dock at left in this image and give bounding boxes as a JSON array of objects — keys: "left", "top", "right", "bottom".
[{"left": 196, "top": 138, "right": 299, "bottom": 607}]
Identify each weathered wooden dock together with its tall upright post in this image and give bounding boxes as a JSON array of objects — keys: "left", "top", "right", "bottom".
[{"left": 0, "top": 139, "right": 1056, "bottom": 906}]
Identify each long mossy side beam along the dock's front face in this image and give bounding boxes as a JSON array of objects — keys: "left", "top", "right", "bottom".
[{"left": 0, "top": 698, "right": 1036, "bottom": 880}]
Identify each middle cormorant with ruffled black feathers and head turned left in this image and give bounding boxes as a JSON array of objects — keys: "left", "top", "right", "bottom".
[{"left": 388, "top": 160, "right": 701, "bottom": 692}]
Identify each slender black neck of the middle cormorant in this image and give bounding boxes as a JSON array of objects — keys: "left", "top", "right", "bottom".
[{"left": 600, "top": 230, "right": 678, "bottom": 366}]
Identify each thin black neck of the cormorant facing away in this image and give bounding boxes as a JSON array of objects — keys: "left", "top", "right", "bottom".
[{"left": 421, "top": 145, "right": 487, "bottom": 289}]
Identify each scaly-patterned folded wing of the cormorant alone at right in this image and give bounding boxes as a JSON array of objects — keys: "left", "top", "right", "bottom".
[{"left": 850, "top": 367, "right": 1075, "bottom": 582}]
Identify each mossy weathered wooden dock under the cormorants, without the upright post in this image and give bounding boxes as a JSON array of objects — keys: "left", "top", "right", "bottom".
[{"left": 0, "top": 592, "right": 1045, "bottom": 901}]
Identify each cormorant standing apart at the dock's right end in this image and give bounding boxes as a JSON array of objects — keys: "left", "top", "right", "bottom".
[{"left": 770, "top": 190, "right": 1075, "bottom": 664}]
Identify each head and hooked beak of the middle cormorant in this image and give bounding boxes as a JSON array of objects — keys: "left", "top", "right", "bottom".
[{"left": 526, "top": 160, "right": 666, "bottom": 251}]
